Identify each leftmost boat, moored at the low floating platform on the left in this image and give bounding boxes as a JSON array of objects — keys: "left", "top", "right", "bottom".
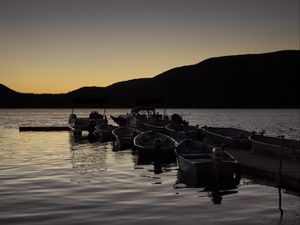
[{"left": 69, "top": 111, "right": 107, "bottom": 137}]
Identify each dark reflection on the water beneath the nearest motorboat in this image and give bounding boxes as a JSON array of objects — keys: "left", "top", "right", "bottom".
[{"left": 175, "top": 169, "right": 241, "bottom": 204}]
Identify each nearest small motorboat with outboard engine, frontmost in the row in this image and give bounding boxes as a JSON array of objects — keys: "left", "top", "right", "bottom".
[{"left": 175, "top": 139, "right": 239, "bottom": 180}]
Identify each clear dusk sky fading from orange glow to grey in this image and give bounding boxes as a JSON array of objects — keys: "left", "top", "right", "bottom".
[{"left": 0, "top": 0, "right": 300, "bottom": 93}]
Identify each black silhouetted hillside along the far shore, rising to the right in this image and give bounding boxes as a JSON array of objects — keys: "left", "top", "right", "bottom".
[{"left": 0, "top": 50, "right": 300, "bottom": 108}]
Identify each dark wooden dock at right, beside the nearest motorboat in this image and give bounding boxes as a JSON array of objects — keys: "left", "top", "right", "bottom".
[{"left": 226, "top": 149, "right": 300, "bottom": 193}]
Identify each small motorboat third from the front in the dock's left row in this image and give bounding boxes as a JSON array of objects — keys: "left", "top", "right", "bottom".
[{"left": 112, "top": 126, "right": 138, "bottom": 149}]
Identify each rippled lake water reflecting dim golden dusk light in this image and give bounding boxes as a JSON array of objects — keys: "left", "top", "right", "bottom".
[{"left": 0, "top": 109, "right": 300, "bottom": 225}]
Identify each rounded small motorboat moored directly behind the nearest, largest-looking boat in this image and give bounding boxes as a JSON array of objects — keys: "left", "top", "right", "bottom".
[{"left": 133, "top": 131, "right": 177, "bottom": 156}]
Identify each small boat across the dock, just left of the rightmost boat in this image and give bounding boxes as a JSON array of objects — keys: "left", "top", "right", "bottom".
[{"left": 201, "top": 126, "right": 251, "bottom": 149}]
